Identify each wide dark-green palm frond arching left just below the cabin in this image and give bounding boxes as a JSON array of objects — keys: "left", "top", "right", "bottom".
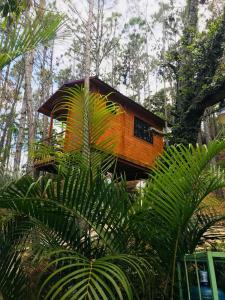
[{"left": 0, "top": 169, "right": 129, "bottom": 252}]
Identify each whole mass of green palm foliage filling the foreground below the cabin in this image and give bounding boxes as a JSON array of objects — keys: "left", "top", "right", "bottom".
[{"left": 0, "top": 141, "right": 225, "bottom": 300}]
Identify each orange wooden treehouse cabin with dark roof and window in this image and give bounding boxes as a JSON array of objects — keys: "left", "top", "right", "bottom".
[{"left": 35, "top": 77, "right": 164, "bottom": 180}]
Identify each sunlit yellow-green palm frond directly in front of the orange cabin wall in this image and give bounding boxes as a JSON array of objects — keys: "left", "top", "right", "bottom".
[{"left": 53, "top": 88, "right": 122, "bottom": 172}]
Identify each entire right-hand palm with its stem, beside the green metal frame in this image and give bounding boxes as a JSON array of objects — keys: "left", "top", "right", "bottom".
[{"left": 131, "top": 141, "right": 225, "bottom": 299}]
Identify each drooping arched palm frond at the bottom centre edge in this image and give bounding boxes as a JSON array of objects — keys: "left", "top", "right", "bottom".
[{"left": 40, "top": 252, "right": 149, "bottom": 300}]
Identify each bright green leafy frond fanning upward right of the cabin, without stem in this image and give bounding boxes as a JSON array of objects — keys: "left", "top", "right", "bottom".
[{"left": 145, "top": 141, "right": 225, "bottom": 230}]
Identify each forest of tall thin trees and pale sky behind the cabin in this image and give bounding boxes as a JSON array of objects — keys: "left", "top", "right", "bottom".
[{"left": 0, "top": 0, "right": 225, "bottom": 174}]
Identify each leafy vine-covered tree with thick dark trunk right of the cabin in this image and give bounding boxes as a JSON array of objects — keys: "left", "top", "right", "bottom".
[{"left": 167, "top": 0, "right": 225, "bottom": 144}]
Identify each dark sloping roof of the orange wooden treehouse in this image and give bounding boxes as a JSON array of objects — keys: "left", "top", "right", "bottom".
[{"left": 38, "top": 76, "right": 165, "bottom": 127}]
